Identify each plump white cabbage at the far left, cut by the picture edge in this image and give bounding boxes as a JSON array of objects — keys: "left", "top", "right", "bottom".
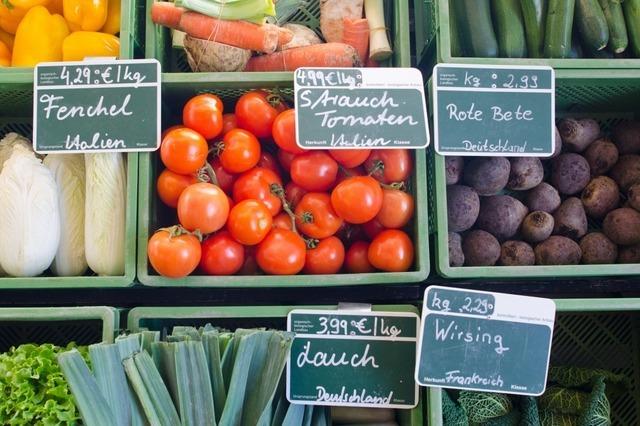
[{"left": 0, "top": 144, "right": 60, "bottom": 277}]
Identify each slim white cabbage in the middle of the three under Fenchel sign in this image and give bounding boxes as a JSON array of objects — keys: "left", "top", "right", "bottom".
[{"left": 44, "top": 154, "right": 87, "bottom": 277}]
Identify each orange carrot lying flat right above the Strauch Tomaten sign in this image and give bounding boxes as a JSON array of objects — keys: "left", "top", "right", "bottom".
[{"left": 245, "top": 43, "right": 360, "bottom": 71}]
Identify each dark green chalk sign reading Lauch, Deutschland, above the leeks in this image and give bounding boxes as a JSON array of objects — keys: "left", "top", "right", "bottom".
[{"left": 287, "top": 310, "right": 420, "bottom": 408}]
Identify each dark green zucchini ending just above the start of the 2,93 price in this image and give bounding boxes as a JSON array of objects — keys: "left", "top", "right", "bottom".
[{"left": 491, "top": 0, "right": 527, "bottom": 58}]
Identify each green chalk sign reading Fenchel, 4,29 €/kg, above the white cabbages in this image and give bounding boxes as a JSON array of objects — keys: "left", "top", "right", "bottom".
[{"left": 33, "top": 59, "right": 161, "bottom": 154}]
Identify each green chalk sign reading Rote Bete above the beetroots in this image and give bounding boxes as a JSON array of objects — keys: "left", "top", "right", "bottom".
[{"left": 432, "top": 64, "right": 555, "bottom": 157}]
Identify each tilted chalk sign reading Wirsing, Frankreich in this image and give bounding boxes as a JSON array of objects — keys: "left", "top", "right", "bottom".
[{"left": 415, "top": 286, "right": 556, "bottom": 396}]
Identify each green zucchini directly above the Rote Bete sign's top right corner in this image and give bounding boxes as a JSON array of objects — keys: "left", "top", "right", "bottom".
[{"left": 544, "top": 0, "right": 576, "bottom": 58}]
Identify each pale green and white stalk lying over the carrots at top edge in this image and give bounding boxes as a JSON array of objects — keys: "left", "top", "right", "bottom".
[{"left": 175, "top": 0, "right": 276, "bottom": 21}]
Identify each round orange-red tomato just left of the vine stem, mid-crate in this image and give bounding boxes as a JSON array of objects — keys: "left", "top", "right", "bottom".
[{"left": 227, "top": 200, "right": 273, "bottom": 246}]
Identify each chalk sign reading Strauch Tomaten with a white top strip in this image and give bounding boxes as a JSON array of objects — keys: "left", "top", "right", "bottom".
[{"left": 294, "top": 68, "right": 429, "bottom": 149}]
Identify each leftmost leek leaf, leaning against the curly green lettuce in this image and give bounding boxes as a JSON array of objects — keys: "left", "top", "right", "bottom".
[{"left": 58, "top": 349, "right": 116, "bottom": 426}]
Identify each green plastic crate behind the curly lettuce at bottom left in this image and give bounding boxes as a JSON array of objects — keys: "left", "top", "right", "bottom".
[{"left": 0, "top": 306, "right": 120, "bottom": 352}]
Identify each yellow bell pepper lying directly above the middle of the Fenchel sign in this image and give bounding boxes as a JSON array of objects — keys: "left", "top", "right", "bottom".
[{"left": 62, "top": 31, "right": 120, "bottom": 61}]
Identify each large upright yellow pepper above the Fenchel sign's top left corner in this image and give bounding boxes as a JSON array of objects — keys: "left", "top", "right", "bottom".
[{"left": 11, "top": 6, "right": 69, "bottom": 67}]
